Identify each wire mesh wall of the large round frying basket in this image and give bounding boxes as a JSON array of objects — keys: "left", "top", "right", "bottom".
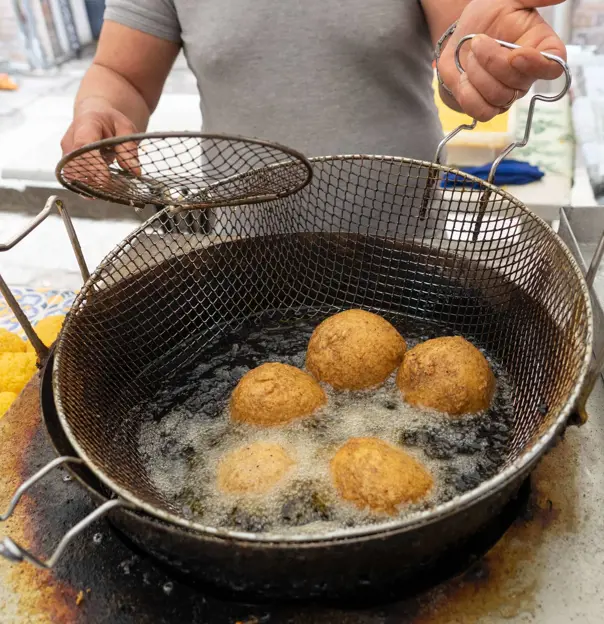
[{"left": 54, "top": 156, "right": 591, "bottom": 529}]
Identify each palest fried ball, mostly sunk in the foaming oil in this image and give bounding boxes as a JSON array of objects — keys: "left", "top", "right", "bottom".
[{"left": 218, "top": 442, "right": 295, "bottom": 494}]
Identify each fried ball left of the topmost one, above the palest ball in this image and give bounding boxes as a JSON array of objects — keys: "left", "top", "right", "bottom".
[{"left": 231, "top": 363, "right": 327, "bottom": 427}]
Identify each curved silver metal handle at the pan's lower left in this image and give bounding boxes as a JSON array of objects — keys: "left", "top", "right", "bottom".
[{"left": 0, "top": 456, "right": 131, "bottom": 569}]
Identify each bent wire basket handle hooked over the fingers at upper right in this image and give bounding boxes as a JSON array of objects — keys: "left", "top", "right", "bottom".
[{"left": 434, "top": 22, "right": 572, "bottom": 236}]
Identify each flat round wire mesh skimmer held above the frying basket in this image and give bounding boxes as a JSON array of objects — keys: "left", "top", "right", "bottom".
[{"left": 56, "top": 133, "right": 312, "bottom": 209}]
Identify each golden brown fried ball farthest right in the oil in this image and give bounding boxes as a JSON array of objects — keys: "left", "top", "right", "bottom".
[{"left": 396, "top": 336, "right": 495, "bottom": 416}]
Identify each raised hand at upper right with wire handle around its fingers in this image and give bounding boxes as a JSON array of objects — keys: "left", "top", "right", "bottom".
[{"left": 438, "top": 0, "right": 566, "bottom": 121}]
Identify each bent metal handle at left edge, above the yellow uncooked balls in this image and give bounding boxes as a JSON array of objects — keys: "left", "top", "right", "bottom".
[{"left": 0, "top": 195, "right": 90, "bottom": 361}]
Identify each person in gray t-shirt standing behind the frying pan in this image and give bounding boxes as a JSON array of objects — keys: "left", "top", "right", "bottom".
[{"left": 62, "top": 0, "right": 565, "bottom": 166}]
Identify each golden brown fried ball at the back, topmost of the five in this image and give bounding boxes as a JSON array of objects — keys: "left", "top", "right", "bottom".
[{"left": 306, "top": 310, "right": 407, "bottom": 390}]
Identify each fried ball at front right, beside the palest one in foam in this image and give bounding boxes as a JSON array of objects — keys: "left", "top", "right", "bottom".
[{"left": 331, "top": 438, "right": 434, "bottom": 515}]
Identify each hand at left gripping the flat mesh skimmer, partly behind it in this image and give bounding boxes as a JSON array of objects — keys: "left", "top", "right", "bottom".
[{"left": 61, "top": 98, "right": 140, "bottom": 186}]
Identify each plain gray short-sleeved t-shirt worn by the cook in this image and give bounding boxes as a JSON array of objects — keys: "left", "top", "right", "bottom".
[{"left": 105, "top": 0, "right": 441, "bottom": 160}]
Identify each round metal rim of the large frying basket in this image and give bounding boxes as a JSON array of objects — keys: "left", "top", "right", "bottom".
[{"left": 52, "top": 154, "right": 593, "bottom": 545}]
